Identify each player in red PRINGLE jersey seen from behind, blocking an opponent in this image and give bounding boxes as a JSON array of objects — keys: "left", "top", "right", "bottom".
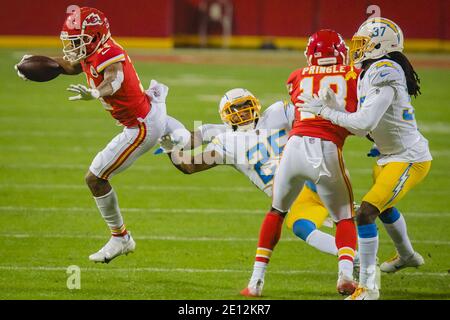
[{"left": 241, "top": 30, "right": 357, "bottom": 296}]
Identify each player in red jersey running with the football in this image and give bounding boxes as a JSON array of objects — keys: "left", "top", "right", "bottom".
[{"left": 14, "top": 7, "right": 190, "bottom": 263}]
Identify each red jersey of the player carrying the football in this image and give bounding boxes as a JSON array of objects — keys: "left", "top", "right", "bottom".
[{"left": 81, "top": 39, "right": 150, "bottom": 127}]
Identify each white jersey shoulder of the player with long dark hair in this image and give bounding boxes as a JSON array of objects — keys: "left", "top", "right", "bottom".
[{"left": 367, "top": 60, "right": 404, "bottom": 87}]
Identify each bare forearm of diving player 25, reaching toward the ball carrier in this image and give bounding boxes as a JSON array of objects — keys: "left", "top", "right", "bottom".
[{"left": 168, "top": 150, "right": 218, "bottom": 174}]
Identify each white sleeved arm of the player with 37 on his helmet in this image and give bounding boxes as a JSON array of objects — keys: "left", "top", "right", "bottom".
[{"left": 321, "top": 86, "right": 394, "bottom": 135}]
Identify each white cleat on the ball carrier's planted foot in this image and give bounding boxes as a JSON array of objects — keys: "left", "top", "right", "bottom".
[{"left": 89, "top": 233, "right": 136, "bottom": 263}]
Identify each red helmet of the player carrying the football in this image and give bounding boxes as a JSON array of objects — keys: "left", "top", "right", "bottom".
[{"left": 60, "top": 6, "right": 111, "bottom": 63}]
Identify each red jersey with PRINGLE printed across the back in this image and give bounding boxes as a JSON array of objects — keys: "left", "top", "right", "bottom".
[{"left": 287, "top": 64, "right": 360, "bottom": 148}]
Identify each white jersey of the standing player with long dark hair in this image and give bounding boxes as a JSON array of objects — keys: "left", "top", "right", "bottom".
[{"left": 325, "top": 59, "right": 432, "bottom": 165}]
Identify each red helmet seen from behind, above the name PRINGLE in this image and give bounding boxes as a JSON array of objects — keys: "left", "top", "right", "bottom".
[{"left": 305, "top": 29, "right": 348, "bottom": 66}]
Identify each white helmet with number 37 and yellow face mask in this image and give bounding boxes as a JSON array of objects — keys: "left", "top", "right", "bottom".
[{"left": 350, "top": 17, "right": 403, "bottom": 65}]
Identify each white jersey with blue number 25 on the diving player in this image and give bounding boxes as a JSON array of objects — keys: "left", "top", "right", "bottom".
[{"left": 199, "top": 101, "right": 294, "bottom": 196}]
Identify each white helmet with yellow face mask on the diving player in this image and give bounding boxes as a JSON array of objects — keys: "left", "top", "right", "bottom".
[{"left": 219, "top": 88, "right": 261, "bottom": 131}]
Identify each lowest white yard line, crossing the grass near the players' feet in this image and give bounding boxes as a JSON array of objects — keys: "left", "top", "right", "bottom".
[{"left": 0, "top": 265, "right": 444, "bottom": 277}]
